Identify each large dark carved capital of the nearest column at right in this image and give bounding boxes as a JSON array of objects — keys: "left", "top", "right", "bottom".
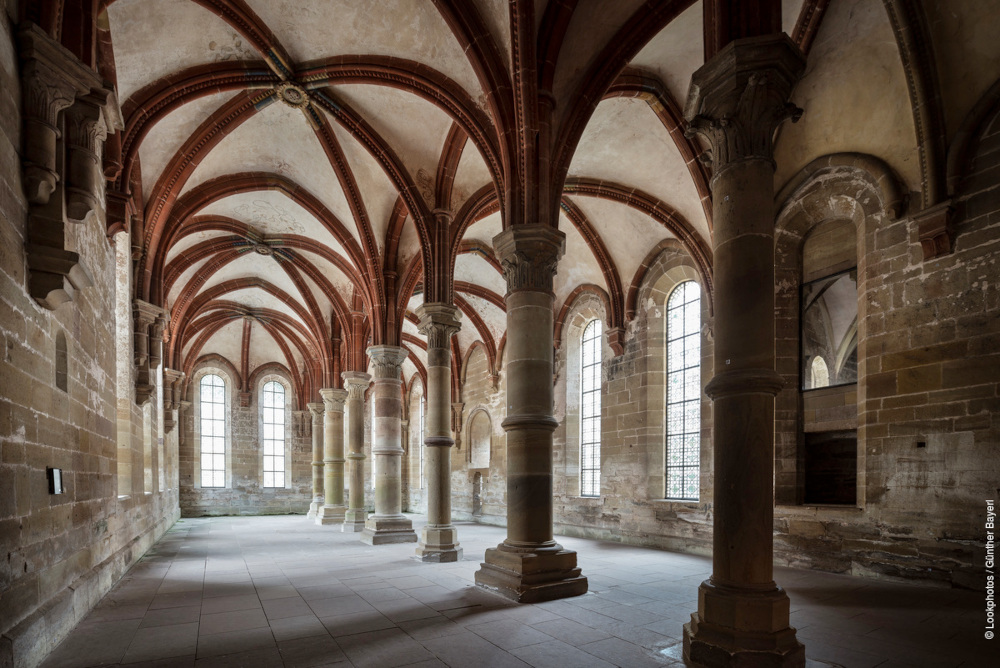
[{"left": 684, "top": 33, "right": 806, "bottom": 180}]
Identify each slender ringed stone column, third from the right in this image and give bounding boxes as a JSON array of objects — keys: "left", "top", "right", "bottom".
[{"left": 417, "top": 303, "right": 462, "bottom": 561}]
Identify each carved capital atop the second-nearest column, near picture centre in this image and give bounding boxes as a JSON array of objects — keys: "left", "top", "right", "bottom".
[{"left": 493, "top": 225, "right": 566, "bottom": 294}]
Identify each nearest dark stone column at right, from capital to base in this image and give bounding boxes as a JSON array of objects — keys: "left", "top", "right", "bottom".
[{"left": 684, "top": 35, "right": 805, "bottom": 666}]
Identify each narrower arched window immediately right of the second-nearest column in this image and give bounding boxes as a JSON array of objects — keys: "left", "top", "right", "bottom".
[{"left": 580, "top": 320, "right": 601, "bottom": 496}]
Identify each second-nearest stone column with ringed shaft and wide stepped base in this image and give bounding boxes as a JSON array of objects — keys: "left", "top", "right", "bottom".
[{"left": 476, "top": 225, "right": 587, "bottom": 603}]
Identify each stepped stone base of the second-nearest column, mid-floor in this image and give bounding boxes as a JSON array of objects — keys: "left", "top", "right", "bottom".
[{"left": 476, "top": 543, "right": 587, "bottom": 603}]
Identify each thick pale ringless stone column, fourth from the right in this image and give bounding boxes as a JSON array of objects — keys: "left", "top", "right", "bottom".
[{"left": 361, "top": 346, "right": 417, "bottom": 545}]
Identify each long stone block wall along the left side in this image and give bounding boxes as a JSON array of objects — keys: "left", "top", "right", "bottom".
[{"left": 0, "top": 11, "right": 177, "bottom": 666}]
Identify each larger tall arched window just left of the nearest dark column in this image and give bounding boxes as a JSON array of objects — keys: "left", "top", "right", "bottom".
[{"left": 666, "top": 281, "right": 701, "bottom": 501}]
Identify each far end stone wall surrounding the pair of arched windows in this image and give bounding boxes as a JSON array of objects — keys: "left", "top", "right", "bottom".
[{"left": 179, "top": 365, "right": 312, "bottom": 517}]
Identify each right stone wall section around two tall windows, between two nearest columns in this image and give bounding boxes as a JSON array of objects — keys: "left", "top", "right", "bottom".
[{"left": 554, "top": 247, "right": 712, "bottom": 554}]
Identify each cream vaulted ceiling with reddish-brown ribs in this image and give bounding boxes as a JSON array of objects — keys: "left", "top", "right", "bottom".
[{"left": 92, "top": 0, "right": 1000, "bottom": 403}]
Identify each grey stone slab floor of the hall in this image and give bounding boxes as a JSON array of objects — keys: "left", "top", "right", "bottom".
[{"left": 43, "top": 516, "right": 1000, "bottom": 668}]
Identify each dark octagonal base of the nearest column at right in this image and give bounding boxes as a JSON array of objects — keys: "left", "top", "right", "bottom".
[{"left": 684, "top": 581, "right": 806, "bottom": 668}]
